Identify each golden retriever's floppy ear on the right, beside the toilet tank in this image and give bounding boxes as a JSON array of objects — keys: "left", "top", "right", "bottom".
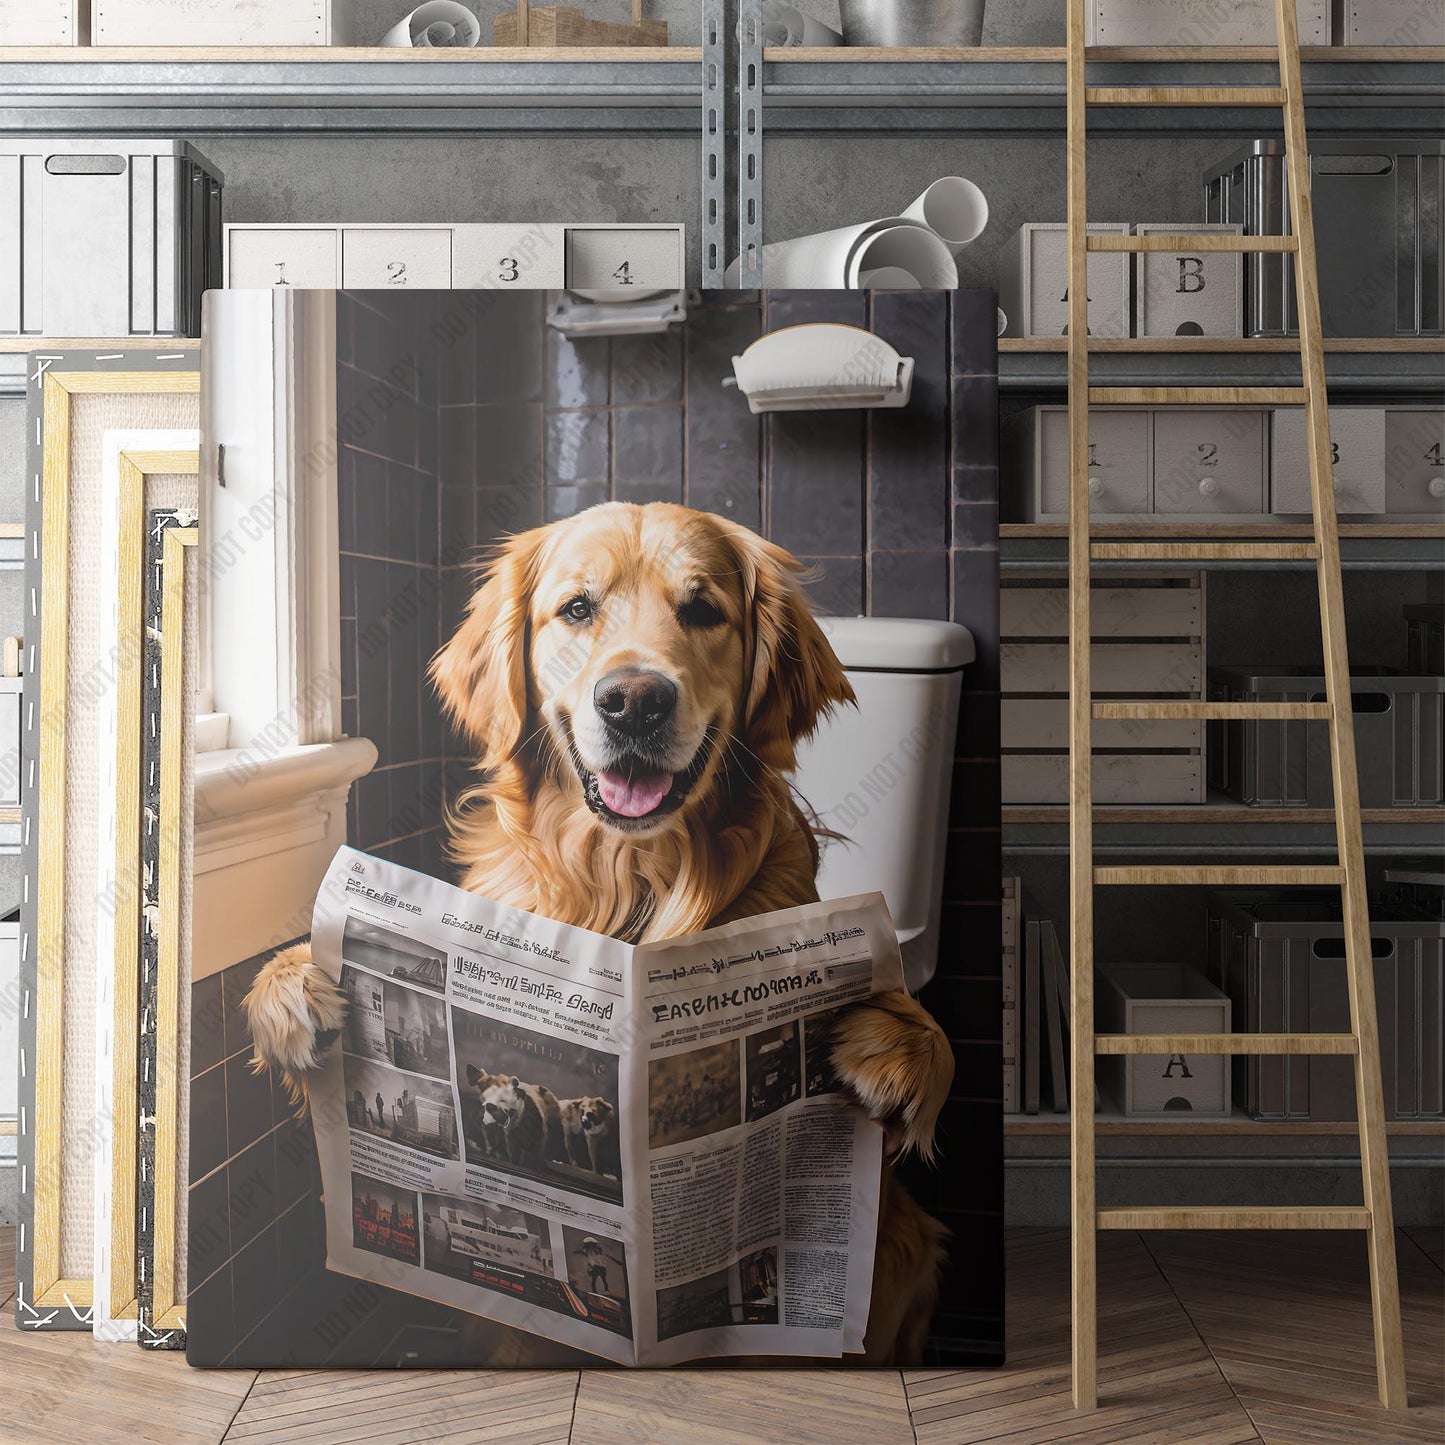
[{"left": 730, "top": 523, "right": 855, "bottom": 773}]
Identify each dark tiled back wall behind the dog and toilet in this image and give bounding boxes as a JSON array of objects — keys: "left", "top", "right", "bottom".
[{"left": 441, "top": 290, "right": 1003, "bottom": 1360}]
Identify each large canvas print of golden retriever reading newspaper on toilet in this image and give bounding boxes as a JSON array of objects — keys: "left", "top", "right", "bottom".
[{"left": 188, "top": 292, "right": 1003, "bottom": 1367}]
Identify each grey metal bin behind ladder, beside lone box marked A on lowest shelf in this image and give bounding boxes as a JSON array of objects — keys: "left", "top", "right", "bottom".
[{"left": 1207, "top": 890, "right": 1445, "bottom": 1120}]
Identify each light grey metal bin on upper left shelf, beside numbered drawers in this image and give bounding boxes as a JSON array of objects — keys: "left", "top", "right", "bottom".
[{"left": 0, "top": 134, "right": 223, "bottom": 337}]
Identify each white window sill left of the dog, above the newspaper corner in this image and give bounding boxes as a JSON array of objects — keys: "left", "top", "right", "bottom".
[{"left": 194, "top": 737, "right": 377, "bottom": 874}]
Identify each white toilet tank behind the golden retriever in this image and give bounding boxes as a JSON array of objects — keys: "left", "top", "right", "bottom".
[{"left": 793, "top": 617, "right": 974, "bottom": 988}]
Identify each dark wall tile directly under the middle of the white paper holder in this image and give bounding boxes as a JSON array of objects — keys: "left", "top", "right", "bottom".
[{"left": 764, "top": 412, "right": 864, "bottom": 555}]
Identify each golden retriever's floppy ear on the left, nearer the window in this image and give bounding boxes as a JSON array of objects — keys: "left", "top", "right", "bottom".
[{"left": 431, "top": 529, "right": 542, "bottom": 767}]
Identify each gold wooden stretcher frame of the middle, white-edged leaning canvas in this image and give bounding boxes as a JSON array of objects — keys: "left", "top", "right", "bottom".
[{"left": 110, "top": 449, "right": 201, "bottom": 1319}]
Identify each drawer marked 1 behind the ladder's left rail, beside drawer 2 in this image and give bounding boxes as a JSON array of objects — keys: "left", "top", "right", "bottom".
[{"left": 1007, "top": 406, "right": 1149, "bottom": 522}]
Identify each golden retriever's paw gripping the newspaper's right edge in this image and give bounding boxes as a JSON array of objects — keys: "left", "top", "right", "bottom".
[{"left": 829, "top": 990, "right": 954, "bottom": 1159}]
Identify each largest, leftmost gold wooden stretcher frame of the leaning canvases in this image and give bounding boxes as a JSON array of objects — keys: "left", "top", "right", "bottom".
[{"left": 30, "top": 370, "right": 201, "bottom": 1309}]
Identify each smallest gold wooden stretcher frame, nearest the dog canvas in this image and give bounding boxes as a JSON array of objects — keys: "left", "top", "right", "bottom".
[{"left": 150, "top": 527, "right": 197, "bottom": 1331}]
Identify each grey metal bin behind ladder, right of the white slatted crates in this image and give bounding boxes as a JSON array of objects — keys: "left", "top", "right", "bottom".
[{"left": 1207, "top": 668, "right": 1445, "bottom": 808}]
